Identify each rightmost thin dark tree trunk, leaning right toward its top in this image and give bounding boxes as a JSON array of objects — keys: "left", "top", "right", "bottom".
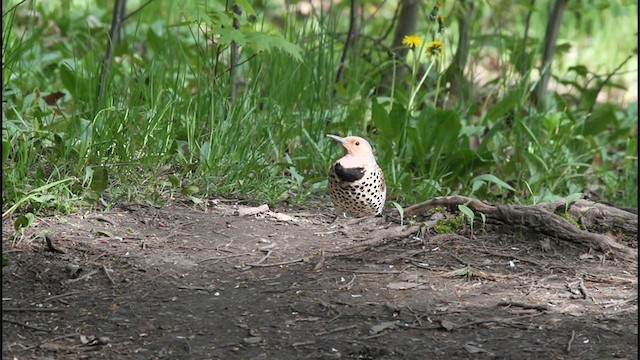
[{"left": 536, "top": 0, "right": 569, "bottom": 106}]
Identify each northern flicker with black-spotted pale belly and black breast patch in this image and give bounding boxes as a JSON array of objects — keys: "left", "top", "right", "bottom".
[{"left": 327, "top": 135, "right": 387, "bottom": 217}]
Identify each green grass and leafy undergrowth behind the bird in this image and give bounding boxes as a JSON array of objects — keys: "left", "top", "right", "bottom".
[{"left": 2, "top": 1, "right": 637, "bottom": 217}]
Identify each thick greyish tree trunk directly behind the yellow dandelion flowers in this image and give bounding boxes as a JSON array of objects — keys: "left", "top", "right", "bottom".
[{"left": 378, "top": 0, "right": 420, "bottom": 94}]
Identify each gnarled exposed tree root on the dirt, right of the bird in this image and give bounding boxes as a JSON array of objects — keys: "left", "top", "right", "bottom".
[{"left": 404, "top": 196, "right": 638, "bottom": 259}]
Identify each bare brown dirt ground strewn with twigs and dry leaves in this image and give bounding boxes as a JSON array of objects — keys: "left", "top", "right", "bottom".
[{"left": 2, "top": 201, "right": 638, "bottom": 359}]
